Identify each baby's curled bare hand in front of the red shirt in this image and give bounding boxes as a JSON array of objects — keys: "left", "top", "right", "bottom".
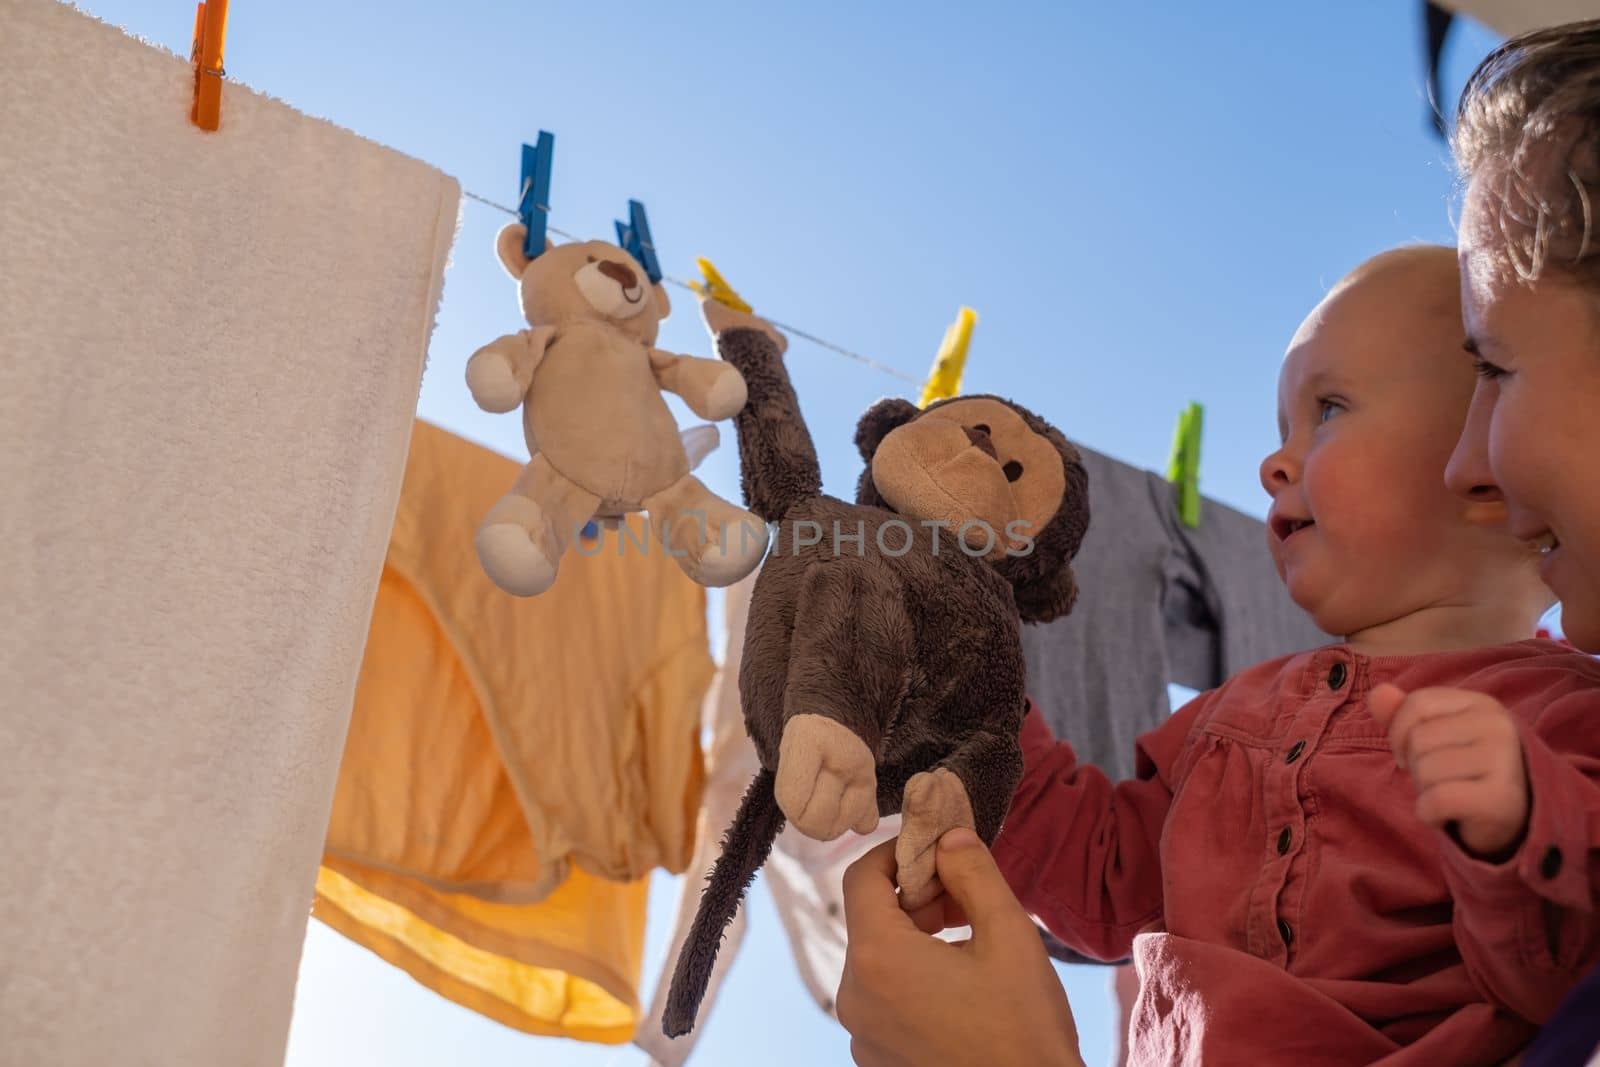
[{"left": 1368, "top": 683, "right": 1530, "bottom": 861}]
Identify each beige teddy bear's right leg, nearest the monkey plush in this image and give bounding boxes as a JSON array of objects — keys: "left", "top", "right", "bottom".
[{"left": 643, "top": 475, "right": 768, "bottom": 587}]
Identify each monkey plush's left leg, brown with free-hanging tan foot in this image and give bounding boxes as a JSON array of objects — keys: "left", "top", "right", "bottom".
[{"left": 774, "top": 557, "right": 912, "bottom": 841}]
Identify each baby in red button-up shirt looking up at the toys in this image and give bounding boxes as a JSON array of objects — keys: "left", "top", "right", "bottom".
[{"left": 994, "top": 248, "right": 1600, "bottom": 1067}]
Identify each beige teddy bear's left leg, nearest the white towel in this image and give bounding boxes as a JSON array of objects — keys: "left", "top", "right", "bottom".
[{"left": 477, "top": 454, "right": 600, "bottom": 597}]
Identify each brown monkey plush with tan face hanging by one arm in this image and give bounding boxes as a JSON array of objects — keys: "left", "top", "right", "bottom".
[{"left": 662, "top": 301, "right": 1088, "bottom": 1037}]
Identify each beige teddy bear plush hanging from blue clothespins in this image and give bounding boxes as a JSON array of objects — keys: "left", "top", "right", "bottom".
[{"left": 467, "top": 222, "right": 768, "bottom": 597}]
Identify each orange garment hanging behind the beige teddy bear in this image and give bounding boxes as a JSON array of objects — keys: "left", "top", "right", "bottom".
[{"left": 314, "top": 421, "right": 715, "bottom": 1043}]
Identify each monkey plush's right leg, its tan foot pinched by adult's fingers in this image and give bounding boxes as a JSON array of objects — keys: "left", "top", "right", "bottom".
[{"left": 894, "top": 731, "right": 1022, "bottom": 910}]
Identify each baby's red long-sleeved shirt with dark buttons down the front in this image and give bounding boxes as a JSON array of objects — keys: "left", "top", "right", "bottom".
[{"left": 994, "top": 641, "right": 1600, "bottom": 1067}]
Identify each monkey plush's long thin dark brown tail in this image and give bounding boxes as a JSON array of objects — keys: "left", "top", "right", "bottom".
[{"left": 661, "top": 769, "right": 784, "bottom": 1037}]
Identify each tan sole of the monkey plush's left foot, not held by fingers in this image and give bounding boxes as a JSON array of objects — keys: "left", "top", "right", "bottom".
[{"left": 774, "top": 715, "right": 878, "bottom": 841}]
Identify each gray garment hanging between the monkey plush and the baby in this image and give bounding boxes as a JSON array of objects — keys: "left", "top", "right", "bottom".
[{"left": 1022, "top": 446, "right": 1330, "bottom": 963}]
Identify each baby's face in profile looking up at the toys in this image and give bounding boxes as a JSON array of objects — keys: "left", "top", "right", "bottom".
[{"left": 1261, "top": 250, "right": 1507, "bottom": 635}]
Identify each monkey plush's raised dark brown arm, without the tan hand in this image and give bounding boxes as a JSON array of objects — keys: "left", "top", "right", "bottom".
[{"left": 715, "top": 326, "right": 822, "bottom": 522}]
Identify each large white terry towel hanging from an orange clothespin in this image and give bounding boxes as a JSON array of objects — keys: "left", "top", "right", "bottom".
[{"left": 0, "top": 0, "right": 459, "bottom": 1067}]
